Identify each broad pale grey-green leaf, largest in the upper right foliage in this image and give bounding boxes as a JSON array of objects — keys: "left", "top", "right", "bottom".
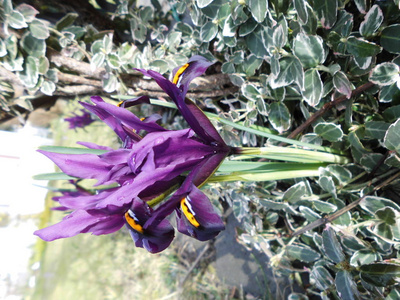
[{"left": 293, "top": 33, "right": 325, "bottom": 68}]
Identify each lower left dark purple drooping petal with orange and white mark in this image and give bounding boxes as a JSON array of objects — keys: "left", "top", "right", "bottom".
[{"left": 125, "top": 198, "right": 175, "bottom": 253}]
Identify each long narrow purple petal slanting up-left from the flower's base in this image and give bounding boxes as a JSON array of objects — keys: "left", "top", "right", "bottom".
[{"left": 137, "top": 69, "right": 225, "bottom": 145}]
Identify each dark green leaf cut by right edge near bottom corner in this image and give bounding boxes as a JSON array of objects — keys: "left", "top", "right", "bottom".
[{"left": 360, "top": 263, "right": 400, "bottom": 287}]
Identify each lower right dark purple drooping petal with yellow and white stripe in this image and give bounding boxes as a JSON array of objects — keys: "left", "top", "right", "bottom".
[{"left": 177, "top": 185, "right": 225, "bottom": 241}]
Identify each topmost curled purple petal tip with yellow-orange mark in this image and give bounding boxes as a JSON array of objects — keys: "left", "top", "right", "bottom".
[{"left": 172, "top": 55, "right": 213, "bottom": 95}]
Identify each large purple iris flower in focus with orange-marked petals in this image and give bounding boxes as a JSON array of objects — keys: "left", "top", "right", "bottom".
[{"left": 35, "top": 56, "right": 231, "bottom": 253}]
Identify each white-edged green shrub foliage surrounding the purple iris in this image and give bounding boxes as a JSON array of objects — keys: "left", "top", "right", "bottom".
[{"left": 0, "top": 0, "right": 400, "bottom": 299}]
